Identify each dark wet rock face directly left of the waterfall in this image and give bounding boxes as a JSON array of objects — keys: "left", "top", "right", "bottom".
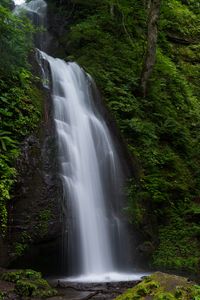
[{"left": 8, "top": 96, "right": 62, "bottom": 272}]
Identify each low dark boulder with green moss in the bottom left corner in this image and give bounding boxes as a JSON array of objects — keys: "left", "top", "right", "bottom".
[{"left": 0, "top": 270, "right": 57, "bottom": 299}]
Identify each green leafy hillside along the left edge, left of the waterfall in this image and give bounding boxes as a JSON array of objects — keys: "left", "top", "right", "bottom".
[{"left": 0, "top": 0, "right": 41, "bottom": 236}]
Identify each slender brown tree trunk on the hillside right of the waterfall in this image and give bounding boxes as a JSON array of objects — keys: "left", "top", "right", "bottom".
[{"left": 140, "top": 0, "right": 161, "bottom": 97}]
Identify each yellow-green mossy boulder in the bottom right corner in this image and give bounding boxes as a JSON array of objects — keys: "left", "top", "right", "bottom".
[{"left": 116, "top": 272, "right": 200, "bottom": 300}]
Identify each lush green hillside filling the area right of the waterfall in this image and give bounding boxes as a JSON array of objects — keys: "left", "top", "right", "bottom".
[{"left": 50, "top": 0, "right": 200, "bottom": 272}]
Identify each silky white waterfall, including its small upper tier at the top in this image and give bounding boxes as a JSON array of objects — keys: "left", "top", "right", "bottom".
[{"left": 14, "top": 0, "right": 145, "bottom": 281}]
